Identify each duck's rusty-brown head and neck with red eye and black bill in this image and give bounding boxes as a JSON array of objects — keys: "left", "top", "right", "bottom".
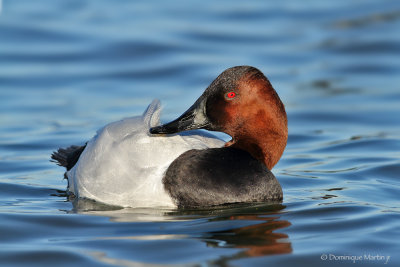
[{"left": 150, "top": 66, "right": 288, "bottom": 169}]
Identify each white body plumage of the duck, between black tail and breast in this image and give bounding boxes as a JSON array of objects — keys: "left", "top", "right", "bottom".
[{"left": 67, "top": 100, "right": 224, "bottom": 207}]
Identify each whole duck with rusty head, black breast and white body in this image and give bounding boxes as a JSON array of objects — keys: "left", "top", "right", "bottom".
[{"left": 51, "top": 66, "right": 288, "bottom": 208}]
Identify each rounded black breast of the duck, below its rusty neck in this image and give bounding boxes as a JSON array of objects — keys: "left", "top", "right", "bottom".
[{"left": 163, "top": 147, "right": 282, "bottom": 207}]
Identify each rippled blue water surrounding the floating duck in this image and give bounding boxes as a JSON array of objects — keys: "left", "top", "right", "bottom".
[{"left": 0, "top": 0, "right": 400, "bottom": 266}]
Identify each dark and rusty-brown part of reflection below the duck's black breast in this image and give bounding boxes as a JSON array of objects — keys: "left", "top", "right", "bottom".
[{"left": 186, "top": 204, "right": 292, "bottom": 261}]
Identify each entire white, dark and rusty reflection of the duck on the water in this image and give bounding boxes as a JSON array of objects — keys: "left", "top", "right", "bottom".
[{"left": 67, "top": 200, "right": 292, "bottom": 262}]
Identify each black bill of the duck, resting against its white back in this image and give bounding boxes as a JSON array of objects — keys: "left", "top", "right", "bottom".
[{"left": 150, "top": 97, "right": 210, "bottom": 134}]
